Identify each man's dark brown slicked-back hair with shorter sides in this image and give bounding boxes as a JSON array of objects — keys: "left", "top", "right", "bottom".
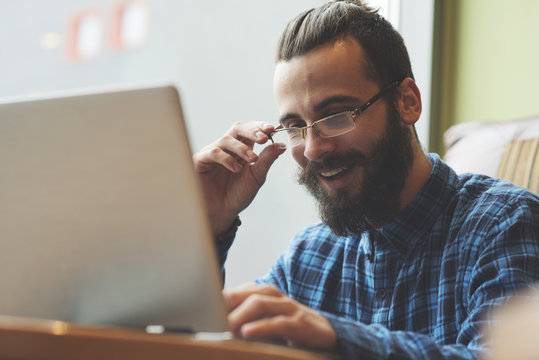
[{"left": 277, "top": 0, "right": 413, "bottom": 88}]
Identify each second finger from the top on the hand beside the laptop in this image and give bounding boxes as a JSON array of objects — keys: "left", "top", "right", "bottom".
[{"left": 228, "top": 294, "right": 296, "bottom": 332}]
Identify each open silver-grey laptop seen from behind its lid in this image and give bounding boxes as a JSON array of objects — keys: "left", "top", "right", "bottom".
[{"left": 0, "top": 86, "right": 227, "bottom": 332}]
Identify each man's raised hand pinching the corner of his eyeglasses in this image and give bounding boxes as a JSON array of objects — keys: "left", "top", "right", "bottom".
[{"left": 193, "top": 122, "right": 286, "bottom": 234}]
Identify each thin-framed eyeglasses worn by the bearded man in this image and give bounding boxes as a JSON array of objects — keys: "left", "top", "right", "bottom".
[{"left": 268, "top": 81, "right": 400, "bottom": 147}]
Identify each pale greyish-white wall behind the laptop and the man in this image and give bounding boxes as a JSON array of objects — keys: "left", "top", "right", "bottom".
[{"left": 0, "top": 0, "right": 431, "bottom": 286}]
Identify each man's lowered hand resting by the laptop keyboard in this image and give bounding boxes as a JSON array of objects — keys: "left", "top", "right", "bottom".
[{"left": 223, "top": 284, "right": 337, "bottom": 350}]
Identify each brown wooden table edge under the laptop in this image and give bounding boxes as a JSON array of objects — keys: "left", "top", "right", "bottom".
[{"left": 0, "top": 316, "right": 334, "bottom": 360}]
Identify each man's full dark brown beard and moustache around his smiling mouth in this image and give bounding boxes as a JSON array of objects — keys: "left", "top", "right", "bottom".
[{"left": 298, "top": 106, "right": 413, "bottom": 236}]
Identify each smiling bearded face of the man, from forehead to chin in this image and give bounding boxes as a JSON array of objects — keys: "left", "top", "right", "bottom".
[{"left": 274, "top": 38, "right": 413, "bottom": 235}]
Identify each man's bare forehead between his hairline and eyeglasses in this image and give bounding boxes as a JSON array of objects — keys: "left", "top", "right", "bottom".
[{"left": 274, "top": 37, "right": 376, "bottom": 108}]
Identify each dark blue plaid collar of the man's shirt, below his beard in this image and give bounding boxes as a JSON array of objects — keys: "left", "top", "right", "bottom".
[{"left": 380, "top": 154, "right": 458, "bottom": 255}]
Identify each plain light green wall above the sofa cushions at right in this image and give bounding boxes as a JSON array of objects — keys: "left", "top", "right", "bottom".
[{"left": 446, "top": 0, "right": 539, "bottom": 123}]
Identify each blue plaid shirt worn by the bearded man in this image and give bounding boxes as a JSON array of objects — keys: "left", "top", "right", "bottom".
[{"left": 220, "top": 154, "right": 539, "bottom": 359}]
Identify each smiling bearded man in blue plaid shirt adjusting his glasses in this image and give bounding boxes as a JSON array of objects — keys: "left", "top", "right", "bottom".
[{"left": 194, "top": 1, "right": 539, "bottom": 359}]
